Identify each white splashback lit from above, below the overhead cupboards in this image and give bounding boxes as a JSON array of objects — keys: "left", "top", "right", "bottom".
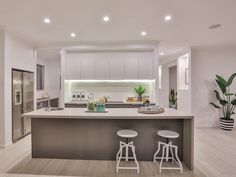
[{"left": 65, "top": 80, "right": 156, "bottom": 103}]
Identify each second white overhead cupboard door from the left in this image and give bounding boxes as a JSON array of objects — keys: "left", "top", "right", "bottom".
[{"left": 80, "top": 54, "right": 94, "bottom": 79}]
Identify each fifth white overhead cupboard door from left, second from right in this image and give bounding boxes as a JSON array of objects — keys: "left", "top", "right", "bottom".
[{"left": 125, "top": 53, "right": 139, "bottom": 79}]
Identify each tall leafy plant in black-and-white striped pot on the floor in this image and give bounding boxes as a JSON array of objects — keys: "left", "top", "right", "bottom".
[{"left": 210, "top": 73, "right": 236, "bottom": 131}]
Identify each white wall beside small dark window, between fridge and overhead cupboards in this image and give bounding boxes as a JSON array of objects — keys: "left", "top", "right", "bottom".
[{"left": 36, "top": 58, "right": 61, "bottom": 99}]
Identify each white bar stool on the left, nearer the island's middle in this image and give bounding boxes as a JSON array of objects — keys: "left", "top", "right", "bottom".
[{"left": 116, "top": 129, "right": 139, "bottom": 173}]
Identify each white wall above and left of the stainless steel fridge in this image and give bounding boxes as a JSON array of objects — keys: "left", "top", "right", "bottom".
[{"left": 2, "top": 31, "right": 36, "bottom": 146}]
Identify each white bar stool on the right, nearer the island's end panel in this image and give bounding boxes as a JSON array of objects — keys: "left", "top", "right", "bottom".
[{"left": 153, "top": 130, "right": 183, "bottom": 174}]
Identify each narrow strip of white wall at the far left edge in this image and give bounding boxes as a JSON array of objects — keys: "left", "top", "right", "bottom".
[{"left": 0, "top": 28, "right": 5, "bottom": 147}]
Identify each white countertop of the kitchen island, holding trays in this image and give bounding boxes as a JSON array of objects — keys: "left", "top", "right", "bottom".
[{"left": 22, "top": 108, "right": 193, "bottom": 119}]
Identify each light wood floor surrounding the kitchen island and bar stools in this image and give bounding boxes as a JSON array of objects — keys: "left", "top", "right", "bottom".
[{"left": 0, "top": 129, "right": 236, "bottom": 177}]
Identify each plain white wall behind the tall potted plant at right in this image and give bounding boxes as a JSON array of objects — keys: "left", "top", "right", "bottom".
[{"left": 192, "top": 46, "right": 236, "bottom": 127}]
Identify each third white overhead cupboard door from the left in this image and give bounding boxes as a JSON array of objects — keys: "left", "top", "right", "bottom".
[{"left": 94, "top": 55, "right": 109, "bottom": 80}]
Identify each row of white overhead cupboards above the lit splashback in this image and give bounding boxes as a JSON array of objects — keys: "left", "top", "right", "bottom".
[{"left": 65, "top": 51, "right": 154, "bottom": 80}]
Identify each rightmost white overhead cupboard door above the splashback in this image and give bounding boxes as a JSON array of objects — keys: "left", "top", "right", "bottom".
[{"left": 139, "top": 53, "right": 154, "bottom": 79}]
